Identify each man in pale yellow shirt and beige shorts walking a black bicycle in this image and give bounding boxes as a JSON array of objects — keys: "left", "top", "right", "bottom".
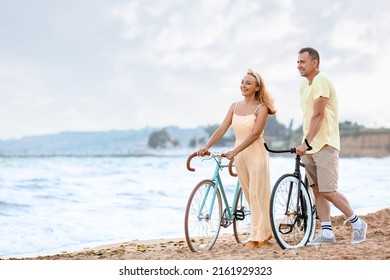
[{"left": 297, "top": 48, "right": 367, "bottom": 245}]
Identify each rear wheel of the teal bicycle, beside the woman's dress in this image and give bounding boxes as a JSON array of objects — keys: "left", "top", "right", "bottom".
[{"left": 233, "top": 187, "right": 252, "bottom": 243}]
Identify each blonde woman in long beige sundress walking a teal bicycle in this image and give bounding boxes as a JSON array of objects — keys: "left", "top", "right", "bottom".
[{"left": 198, "top": 69, "right": 276, "bottom": 248}]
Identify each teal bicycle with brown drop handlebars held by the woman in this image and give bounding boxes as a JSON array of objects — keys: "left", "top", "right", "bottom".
[{"left": 184, "top": 152, "right": 251, "bottom": 252}]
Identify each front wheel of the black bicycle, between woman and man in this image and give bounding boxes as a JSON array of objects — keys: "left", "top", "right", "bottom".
[{"left": 270, "top": 174, "right": 313, "bottom": 249}]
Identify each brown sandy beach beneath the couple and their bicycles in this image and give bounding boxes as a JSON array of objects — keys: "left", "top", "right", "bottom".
[{"left": 6, "top": 208, "right": 390, "bottom": 260}]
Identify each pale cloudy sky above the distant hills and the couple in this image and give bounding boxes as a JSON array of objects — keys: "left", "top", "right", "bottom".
[{"left": 0, "top": 0, "right": 390, "bottom": 139}]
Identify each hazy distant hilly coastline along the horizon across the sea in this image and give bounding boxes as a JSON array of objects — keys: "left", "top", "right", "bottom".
[{"left": 0, "top": 121, "right": 390, "bottom": 157}]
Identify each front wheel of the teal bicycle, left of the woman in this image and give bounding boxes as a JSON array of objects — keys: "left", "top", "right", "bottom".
[{"left": 184, "top": 180, "right": 222, "bottom": 252}]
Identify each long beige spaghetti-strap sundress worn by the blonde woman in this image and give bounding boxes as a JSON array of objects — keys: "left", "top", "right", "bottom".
[{"left": 232, "top": 103, "right": 272, "bottom": 242}]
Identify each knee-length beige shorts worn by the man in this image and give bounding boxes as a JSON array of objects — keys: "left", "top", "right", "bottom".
[{"left": 302, "top": 145, "right": 339, "bottom": 192}]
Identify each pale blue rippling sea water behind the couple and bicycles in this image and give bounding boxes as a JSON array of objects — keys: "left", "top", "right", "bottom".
[{"left": 0, "top": 154, "right": 390, "bottom": 258}]
